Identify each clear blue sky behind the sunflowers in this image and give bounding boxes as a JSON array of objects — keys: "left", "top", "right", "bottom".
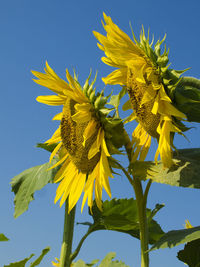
[{"left": 0, "top": 0, "right": 200, "bottom": 267}]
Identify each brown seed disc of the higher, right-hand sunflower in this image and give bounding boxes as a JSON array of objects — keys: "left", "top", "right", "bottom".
[{"left": 127, "top": 70, "right": 160, "bottom": 138}]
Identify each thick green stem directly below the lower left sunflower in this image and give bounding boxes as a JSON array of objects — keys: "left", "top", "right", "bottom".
[{"left": 59, "top": 199, "right": 76, "bottom": 267}]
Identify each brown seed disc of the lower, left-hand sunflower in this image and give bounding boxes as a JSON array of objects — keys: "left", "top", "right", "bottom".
[{"left": 61, "top": 98, "right": 100, "bottom": 173}]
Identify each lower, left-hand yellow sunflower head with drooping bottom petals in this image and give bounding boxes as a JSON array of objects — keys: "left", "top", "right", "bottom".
[{"left": 32, "top": 63, "right": 112, "bottom": 211}]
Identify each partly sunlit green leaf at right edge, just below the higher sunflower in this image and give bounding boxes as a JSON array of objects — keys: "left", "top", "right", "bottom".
[{"left": 131, "top": 148, "right": 200, "bottom": 188}]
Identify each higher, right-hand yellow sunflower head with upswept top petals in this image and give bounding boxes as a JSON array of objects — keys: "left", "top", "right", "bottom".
[{"left": 94, "top": 14, "right": 186, "bottom": 168}]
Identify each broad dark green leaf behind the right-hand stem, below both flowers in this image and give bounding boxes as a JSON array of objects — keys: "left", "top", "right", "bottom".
[{"left": 78, "top": 199, "right": 164, "bottom": 244}]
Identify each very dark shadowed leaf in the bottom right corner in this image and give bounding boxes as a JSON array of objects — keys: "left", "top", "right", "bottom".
[{"left": 177, "top": 239, "right": 200, "bottom": 267}]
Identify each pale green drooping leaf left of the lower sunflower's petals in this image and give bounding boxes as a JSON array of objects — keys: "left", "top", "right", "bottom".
[{"left": 11, "top": 159, "right": 59, "bottom": 218}]
